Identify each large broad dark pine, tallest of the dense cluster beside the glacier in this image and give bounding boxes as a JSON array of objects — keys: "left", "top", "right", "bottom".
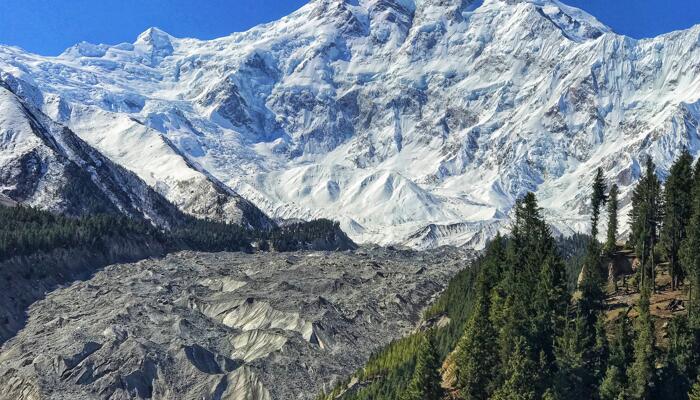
[{"left": 492, "top": 193, "right": 569, "bottom": 397}]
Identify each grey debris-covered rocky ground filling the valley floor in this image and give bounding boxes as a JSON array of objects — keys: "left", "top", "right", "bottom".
[{"left": 0, "top": 248, "right": 471, "bottom": 400}]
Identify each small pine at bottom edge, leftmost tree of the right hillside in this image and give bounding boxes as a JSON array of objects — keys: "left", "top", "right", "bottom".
[{"left": 402, "top": 332, "right": 444, "bottom": 400}]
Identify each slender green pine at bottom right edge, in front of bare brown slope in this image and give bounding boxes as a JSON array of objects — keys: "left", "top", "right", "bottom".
[{"left": 628, "top": 288, "right": 655, "bottom": 400}]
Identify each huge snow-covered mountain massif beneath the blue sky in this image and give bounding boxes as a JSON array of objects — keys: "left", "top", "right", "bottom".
[{"left": 0, "top": 0, "right": 700, "bottom": 247}]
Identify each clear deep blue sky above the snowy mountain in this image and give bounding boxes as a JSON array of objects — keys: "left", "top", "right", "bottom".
[{"left": 0, "top": 0, "right": 700, "bottom": 55}]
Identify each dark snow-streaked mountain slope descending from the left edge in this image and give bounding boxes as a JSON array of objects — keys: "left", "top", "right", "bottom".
[{"left": 0, "top": 81, "right": 183, "bottom": 227}]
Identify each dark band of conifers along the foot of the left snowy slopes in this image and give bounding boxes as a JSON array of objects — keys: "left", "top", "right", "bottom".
[{"left": 0, "top": 206, "right": 355, "bottom": 261}]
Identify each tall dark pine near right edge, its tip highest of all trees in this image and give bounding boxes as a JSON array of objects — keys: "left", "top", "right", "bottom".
[{"left": 660, "top": 150, "right": 693, "bottom": 290}]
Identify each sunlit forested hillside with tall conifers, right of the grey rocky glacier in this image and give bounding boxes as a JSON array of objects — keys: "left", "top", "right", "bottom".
[{"left": 321, "top": 151, "right": 700, "bottom": 400}]
